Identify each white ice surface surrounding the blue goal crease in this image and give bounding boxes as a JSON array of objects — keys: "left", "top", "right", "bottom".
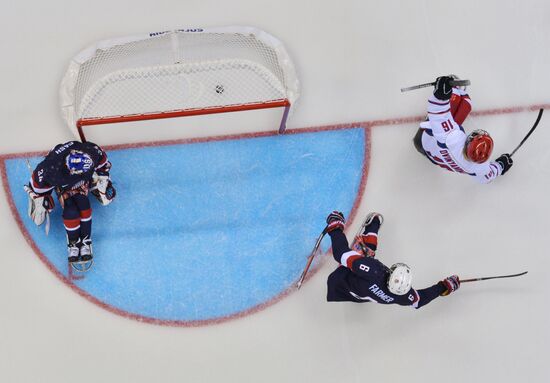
[{"left": 0, "top": 0, "right": 550, "bottom": 382}]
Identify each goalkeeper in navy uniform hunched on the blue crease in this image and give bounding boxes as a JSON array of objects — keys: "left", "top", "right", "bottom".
[{"left": 25, "top": 141, "right": 116, "bottom": 271}]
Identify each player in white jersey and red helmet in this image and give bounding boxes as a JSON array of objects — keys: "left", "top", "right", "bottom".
[{"left": 413, "top": 76, "right": 513, "bottom": 183}]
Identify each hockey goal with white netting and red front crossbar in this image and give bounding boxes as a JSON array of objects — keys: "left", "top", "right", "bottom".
[{"left": 60, "top": 27, "right": 299, "bottom": 141}]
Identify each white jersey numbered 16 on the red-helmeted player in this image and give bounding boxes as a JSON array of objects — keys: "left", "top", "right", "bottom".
[{"left": 420, "top": 88, "right": 502, "bottom": 183}]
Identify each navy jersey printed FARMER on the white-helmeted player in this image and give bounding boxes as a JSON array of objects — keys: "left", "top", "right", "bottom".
[{"left": 327, "top": 229, "right": 446, "bottom": 308}]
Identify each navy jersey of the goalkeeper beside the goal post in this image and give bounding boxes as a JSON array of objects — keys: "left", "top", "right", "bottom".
[{"left": 29, "top": 141, "right": 111, "bottom": 194}]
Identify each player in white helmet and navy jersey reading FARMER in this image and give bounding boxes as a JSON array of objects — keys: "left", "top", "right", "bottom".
[{"left": 327, "top": 211, "right": 460, "bottom": 309}]
